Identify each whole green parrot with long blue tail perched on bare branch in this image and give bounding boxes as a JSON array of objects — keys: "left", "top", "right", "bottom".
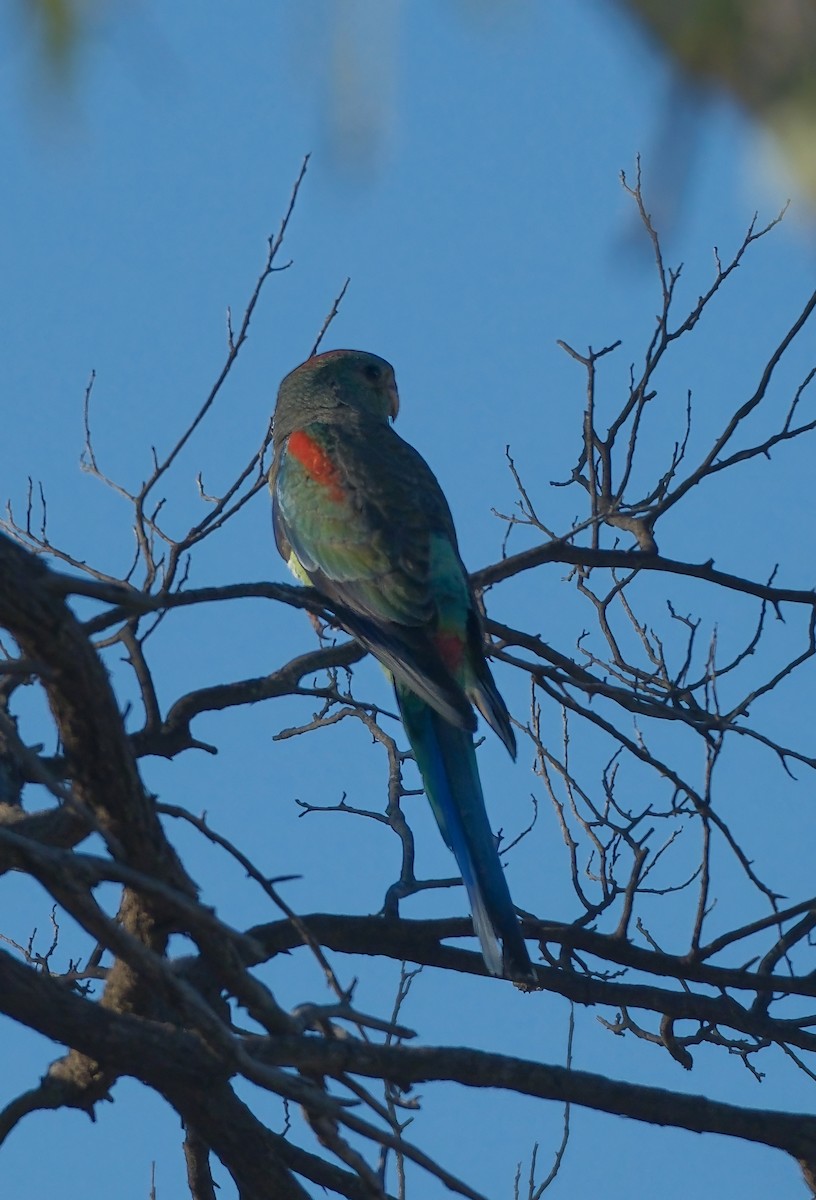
[{"left": 269, "top": 350, "right": 533, "bottom": 980}]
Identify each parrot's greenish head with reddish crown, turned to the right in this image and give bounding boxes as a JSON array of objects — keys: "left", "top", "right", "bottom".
[{"left": 275, "top": 350, "right": 400, "bottom": 436}]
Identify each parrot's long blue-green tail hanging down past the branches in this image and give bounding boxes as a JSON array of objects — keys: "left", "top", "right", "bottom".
[{"left": 395, "top": 683, "right": 534, "bottom": 980}]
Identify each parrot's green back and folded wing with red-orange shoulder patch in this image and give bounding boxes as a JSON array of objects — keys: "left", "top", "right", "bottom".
[{"left": 270, "top": 425, "right": 475, "bottom": 730}]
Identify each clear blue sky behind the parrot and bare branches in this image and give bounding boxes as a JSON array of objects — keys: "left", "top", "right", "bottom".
[{"left": 0, "top": 0, "right": 815, "bottom": 1200}]
